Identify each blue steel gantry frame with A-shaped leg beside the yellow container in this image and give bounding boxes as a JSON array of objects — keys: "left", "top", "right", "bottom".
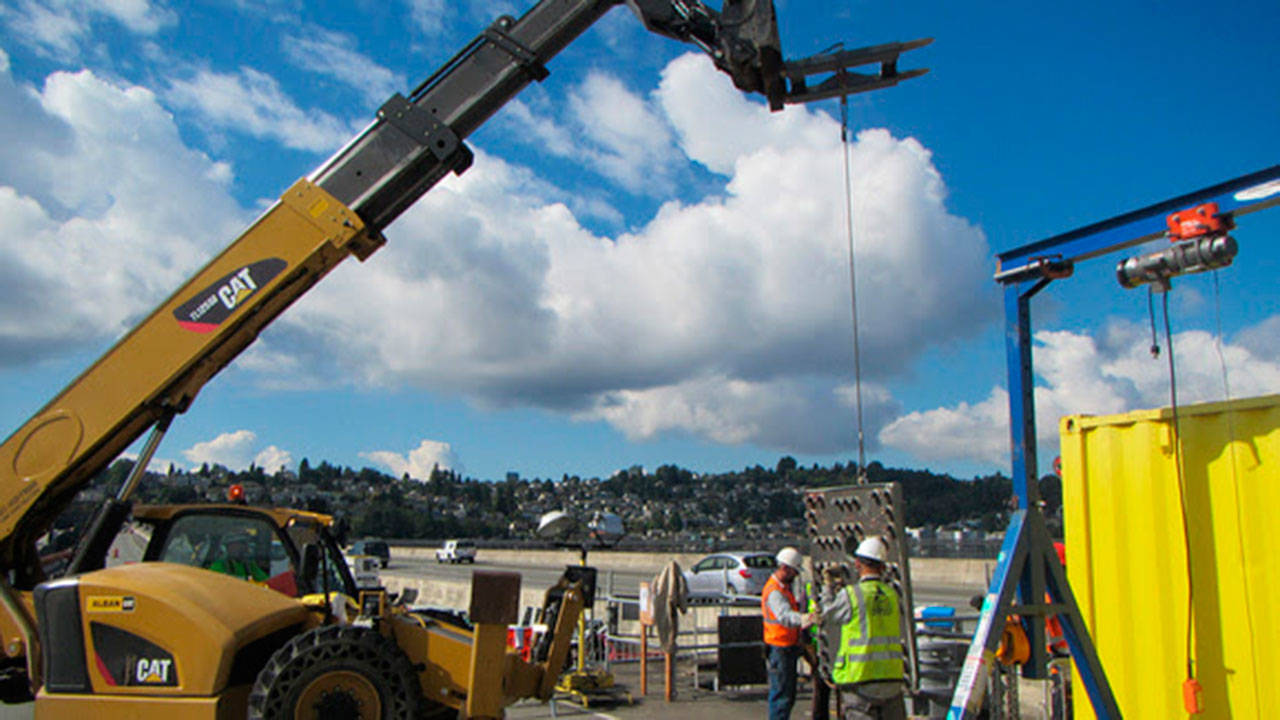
[{"left": 947, "top": 165, "right": 1280, "bottom": 720}]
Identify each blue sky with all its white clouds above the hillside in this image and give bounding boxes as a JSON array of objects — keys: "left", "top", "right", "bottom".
[{"left": 0, "top": 0, "right": 1280, "bottom": 478}]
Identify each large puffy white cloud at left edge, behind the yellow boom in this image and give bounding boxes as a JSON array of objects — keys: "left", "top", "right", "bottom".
[{"left": 0, "top": 60, "right": 247, "bottom": 366}]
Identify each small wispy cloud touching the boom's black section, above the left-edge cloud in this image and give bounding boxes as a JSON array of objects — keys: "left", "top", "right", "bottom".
[{"left": 165, "top": 68, "right": 355, "bottom": 152}]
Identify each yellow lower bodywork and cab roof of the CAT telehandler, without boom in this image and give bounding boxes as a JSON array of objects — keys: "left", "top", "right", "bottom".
[{"left": 24, "top": 505, "right": 582, "bottom": 720}]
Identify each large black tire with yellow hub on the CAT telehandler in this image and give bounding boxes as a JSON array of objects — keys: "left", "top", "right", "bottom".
[{"left": 248, "top": 625, "right": 426, "bottom": 720}]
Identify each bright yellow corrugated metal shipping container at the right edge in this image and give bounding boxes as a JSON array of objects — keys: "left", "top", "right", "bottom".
[{"left": 1060, "top": 395, "right": 1280, "bottom": 720}]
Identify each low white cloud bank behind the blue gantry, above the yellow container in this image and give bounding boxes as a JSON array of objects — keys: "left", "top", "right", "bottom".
[{"left": 879, "top": 315, "right": 1280, "bottom": 466}]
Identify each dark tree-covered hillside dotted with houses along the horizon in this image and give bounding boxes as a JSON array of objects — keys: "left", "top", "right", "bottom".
[{"left": 55, "top": 456, "right": 1061, "bottom": 539}]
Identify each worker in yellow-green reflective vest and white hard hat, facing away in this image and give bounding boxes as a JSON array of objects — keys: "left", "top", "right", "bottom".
[{"left": 822, "top": 537, "right": 906, "bottom": 720}]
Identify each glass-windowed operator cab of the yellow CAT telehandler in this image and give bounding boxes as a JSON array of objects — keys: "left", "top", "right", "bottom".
[{"left": 133, "top": 505, "right": 356, "bottom": 597}]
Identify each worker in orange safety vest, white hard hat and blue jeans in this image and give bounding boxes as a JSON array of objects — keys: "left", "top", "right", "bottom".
[{"left": 760, "top": 547, "right": 817, "bottom": 720}]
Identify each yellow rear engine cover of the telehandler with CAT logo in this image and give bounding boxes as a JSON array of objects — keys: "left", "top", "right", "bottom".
[{"left": 36, "top": 562, "right": 309, "bottom": 717}]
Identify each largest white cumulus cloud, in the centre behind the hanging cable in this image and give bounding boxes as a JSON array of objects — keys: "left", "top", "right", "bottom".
[{"left": 247, "top": 58, "right": 998, "bottom": 447}]
